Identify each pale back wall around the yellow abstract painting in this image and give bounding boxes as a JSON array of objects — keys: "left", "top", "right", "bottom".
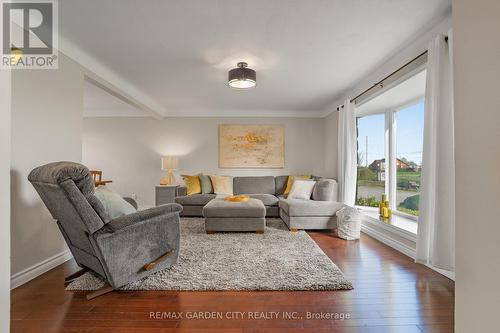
[{"left": 83, "top": 118, "right": 325, "bottom": 206}]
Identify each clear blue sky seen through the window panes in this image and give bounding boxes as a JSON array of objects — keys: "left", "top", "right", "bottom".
[{"left": 358, "top": 100, "right": 424, "bottom": 165}]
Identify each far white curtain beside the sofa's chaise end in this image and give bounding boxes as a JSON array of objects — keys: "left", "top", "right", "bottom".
[{"left": 338, "top": 100, "right": 357, "bottom": 206}]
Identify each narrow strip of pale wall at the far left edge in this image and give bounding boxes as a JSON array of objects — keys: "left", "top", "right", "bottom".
[{"left": 0, "top": 70, "right": 11, "bottom": 332}]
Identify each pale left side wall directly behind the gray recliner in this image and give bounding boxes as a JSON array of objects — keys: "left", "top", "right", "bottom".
[{"left": 11, "top": 53, "right": 83, "bottom": 278}]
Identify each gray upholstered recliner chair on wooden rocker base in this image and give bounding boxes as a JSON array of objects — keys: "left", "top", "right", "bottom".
[{"left": 28, "top": 162, "right": 182, "bottom": 299}]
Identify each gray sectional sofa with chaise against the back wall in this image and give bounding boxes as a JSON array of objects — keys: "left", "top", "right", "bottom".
[{"left": 175, "top": 176, "right": 343, "bottom": 230}]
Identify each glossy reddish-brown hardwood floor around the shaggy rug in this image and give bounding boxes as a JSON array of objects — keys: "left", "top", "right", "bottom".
[{"left": 11, "top": 232, "right": 455, "bottom": 333}]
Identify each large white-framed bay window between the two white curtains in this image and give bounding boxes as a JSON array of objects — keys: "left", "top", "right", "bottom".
[{"left": 356, "top": 70, "right": 426, "bottom": 227}]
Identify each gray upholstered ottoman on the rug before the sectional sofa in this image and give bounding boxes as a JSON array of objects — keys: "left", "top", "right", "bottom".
[{"left": 203, "top": 198, "right": 266, "bottom": 234}]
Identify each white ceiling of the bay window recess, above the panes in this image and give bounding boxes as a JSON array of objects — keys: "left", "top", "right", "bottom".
[{"left": 356, "top": 70, "right": 427, "bottom": 115}]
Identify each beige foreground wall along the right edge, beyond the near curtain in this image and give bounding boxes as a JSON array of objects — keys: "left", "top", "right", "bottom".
[{"left": 453, "top": 0, "right": 500, "bottom": 333}]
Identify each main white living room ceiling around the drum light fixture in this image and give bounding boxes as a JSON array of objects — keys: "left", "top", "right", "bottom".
[{"left": 59, "top": 0, "right": 451, "bottom": 116}]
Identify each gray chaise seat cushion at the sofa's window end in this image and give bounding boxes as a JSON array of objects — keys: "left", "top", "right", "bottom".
[{"left": 279, "top": 199, "right": 344, "bottom": 216}]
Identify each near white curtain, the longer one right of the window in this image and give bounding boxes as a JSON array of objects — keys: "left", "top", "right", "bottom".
[{"left": 416, "top": 30, "right": 455, "bottom": 271}]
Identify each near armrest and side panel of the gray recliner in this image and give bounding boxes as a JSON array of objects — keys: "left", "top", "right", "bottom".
[{"left": 90, "top": 204, "right": 181, "bottom": 288}]
